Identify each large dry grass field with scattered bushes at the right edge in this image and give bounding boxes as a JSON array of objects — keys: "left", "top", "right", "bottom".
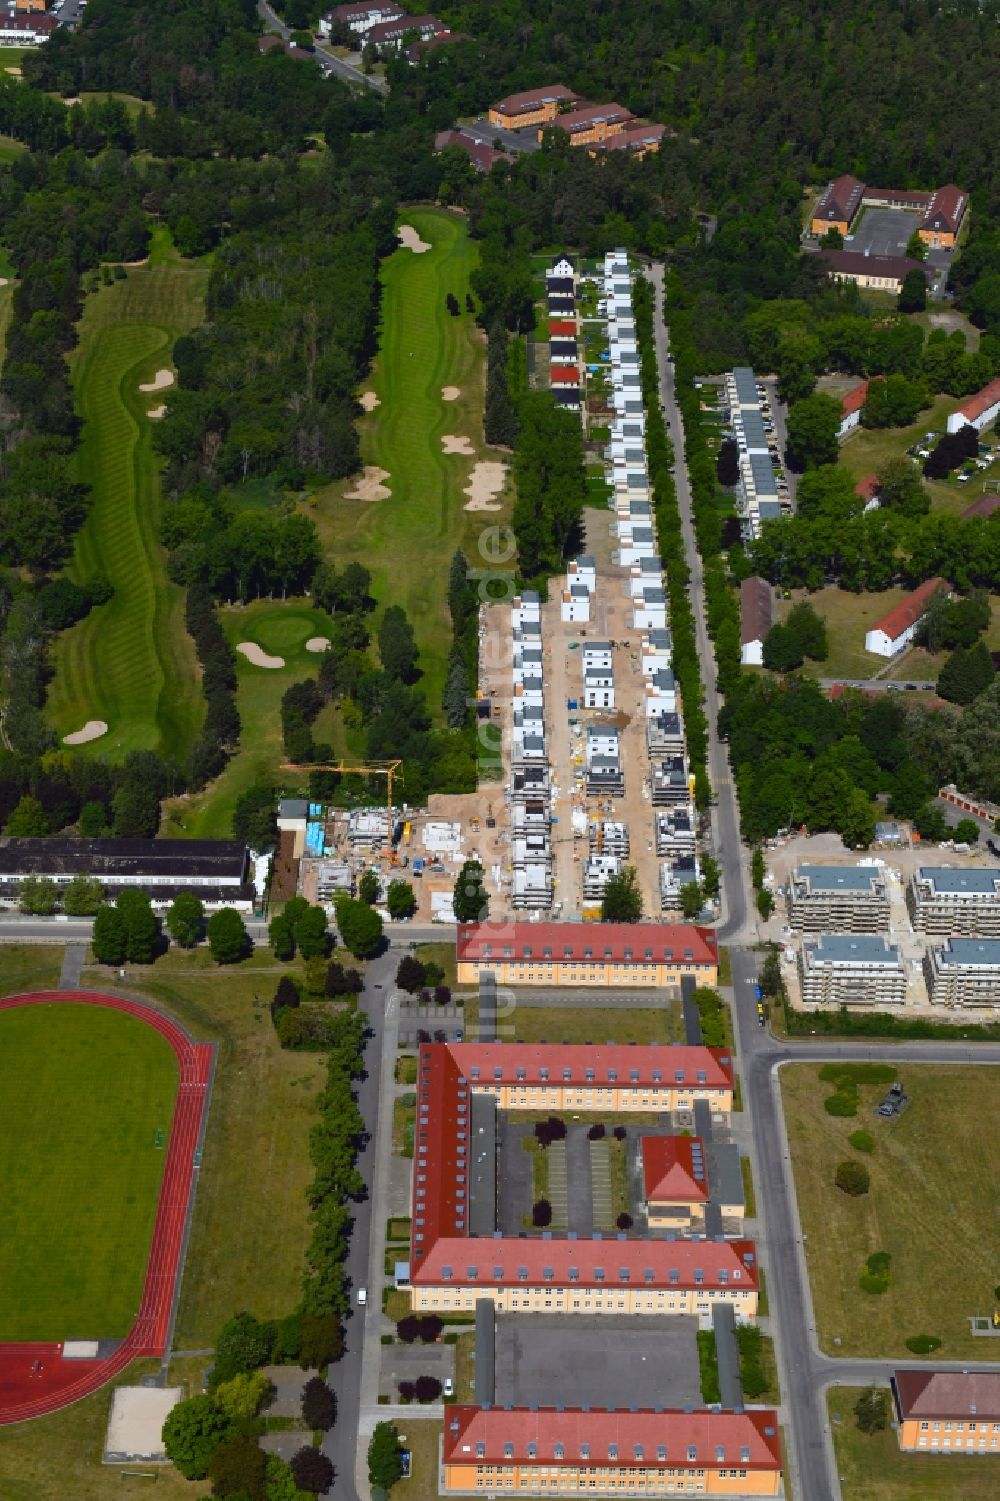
[{"left": 781, "top": 1064, "right": 1000, "bottom": 1360}]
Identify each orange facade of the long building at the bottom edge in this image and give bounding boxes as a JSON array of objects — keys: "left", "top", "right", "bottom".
[{"left": 441, "top": 1463, "right": 781, "bottom": 1496}]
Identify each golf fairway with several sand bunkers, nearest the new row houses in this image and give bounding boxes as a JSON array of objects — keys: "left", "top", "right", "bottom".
[{"left": 311, "top": 209, "right": 509, "bottom": 714}]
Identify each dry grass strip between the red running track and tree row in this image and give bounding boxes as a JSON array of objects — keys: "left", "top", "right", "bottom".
[{"left": 83, "top": 949, "right": 326, "bottom": 1350}]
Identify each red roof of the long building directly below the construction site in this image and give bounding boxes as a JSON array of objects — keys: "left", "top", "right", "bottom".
[{"left": 455, "top": 923, "right": 718, "bottom": 964}]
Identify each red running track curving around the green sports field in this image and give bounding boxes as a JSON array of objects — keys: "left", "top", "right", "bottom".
[{"left": 0, "top": 991, "right": 212, "bottom": 1424}]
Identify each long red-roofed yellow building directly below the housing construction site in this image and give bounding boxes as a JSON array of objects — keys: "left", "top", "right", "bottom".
[{"left": 455, "top": 922, "right": 719, "bottom": 988}]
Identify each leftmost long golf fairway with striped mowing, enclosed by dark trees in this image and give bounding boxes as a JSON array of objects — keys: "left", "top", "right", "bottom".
[{"left": 48, "top": 231, "right": 209, "bottom": 760}]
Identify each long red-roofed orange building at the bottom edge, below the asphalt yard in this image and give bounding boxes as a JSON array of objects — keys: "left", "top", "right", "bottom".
[{"left": 441, "top": 1406, "right": 782, "bottom": 1496}]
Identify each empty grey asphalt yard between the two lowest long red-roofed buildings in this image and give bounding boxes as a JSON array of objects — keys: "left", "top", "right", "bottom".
[{"left": 497, "top": 1313, "right": 701, "bottom": 1408}]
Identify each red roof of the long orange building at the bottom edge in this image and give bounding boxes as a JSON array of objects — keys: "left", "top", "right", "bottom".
[{"left": 443, "top": 1406, "right": 781, "bottom": 1471}]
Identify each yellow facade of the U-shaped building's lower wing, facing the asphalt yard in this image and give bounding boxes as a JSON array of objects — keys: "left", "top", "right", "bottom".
[{"left": 410, "top": 1282, "right": 757, "bottom": 1322}]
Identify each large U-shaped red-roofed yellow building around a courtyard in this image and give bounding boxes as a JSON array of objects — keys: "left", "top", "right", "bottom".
[{"left": 410, "top": 1043, "right": 747, "bottom": 1319}]
